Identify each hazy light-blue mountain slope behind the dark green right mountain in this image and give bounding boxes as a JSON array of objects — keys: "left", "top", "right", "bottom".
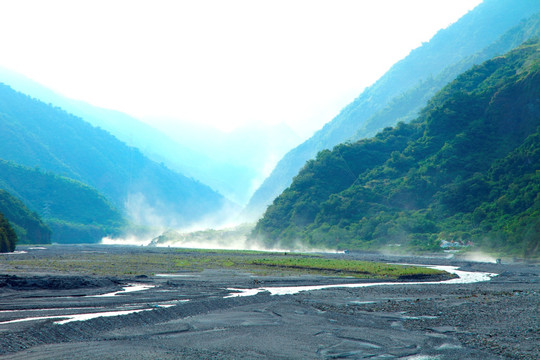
[{"left": 245, "top": 0, "right": 540, "bottom": 218}]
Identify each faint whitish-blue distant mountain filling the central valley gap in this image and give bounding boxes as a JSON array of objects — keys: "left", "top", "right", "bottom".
[{"left": 146, "top": 120, "right": 300, "bottom": 204}]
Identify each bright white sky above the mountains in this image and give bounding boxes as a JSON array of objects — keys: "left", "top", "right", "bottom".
[{"left": 0, "top": 0, "right": 481, "bottom": 136}]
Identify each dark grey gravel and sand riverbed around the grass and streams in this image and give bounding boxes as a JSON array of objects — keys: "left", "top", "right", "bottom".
[{"left": 0, "top": 246, "right": 540, "bottom": 360}]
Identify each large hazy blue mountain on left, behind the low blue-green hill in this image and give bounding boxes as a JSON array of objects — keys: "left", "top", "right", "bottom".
[{"left": 0, "top": 84, "right": 228, "bottom": 231}]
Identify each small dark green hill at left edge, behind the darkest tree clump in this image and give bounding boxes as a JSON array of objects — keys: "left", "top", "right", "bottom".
[{"left": 0, "top": 190, "right": 51, "bottom": 246}]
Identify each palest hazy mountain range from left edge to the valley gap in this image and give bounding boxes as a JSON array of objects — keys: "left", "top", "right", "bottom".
[{"left": 0, "top": 68, "right": 300, "bottom": 204}]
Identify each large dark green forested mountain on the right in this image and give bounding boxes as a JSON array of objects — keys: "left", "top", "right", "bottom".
[{"left": 253, "top": 40, "right": 540, "bottom": 256}]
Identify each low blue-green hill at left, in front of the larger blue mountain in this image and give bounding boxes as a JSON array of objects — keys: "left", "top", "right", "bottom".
[{"left": 0, "top": 160, "right": 127, "bottom": 243}]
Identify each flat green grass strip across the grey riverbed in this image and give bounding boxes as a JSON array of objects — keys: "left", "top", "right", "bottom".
[{"left": 2, "top": 249, "right": 444, "bottom": 279}]
